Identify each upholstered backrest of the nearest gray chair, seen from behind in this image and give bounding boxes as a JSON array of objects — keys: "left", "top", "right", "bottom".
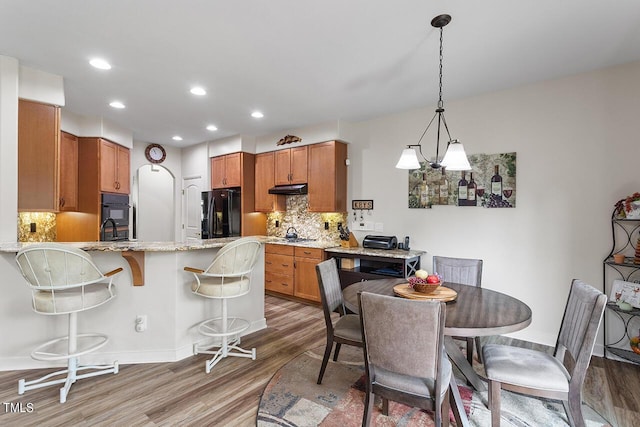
[{"left": 358, "top": 292, "right": 446, "bottom": 384}]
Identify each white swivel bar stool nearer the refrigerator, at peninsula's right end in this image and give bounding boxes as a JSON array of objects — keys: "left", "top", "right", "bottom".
[{"left": 184, "top": 237, "right": 261, "bottom": 374}]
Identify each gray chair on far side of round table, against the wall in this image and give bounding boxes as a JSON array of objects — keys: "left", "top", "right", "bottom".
[{"left": 433, "top": 256, "right": 482, "bottom": 366}]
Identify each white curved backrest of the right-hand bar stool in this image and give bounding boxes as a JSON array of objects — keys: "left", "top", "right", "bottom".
[{"left": 205, "top": 237, "right": 261, "bottom": 277}]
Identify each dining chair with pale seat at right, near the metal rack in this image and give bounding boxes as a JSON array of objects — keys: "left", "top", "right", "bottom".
[{"left": 483, "top": 280, "right": 607, "bottom": 427}]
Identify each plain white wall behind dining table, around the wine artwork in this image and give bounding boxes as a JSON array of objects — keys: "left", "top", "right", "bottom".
[{"left": 349, "top": 62, "right": 640, "bottom": 345}]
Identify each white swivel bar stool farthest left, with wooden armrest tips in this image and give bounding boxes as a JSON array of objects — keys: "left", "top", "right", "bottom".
[{"left": 16, "top": 243, "right": 122, "bottom": 403}]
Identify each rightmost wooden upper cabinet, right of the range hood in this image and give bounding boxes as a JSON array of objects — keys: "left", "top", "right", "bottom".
[{"left": 308, "top": 141, "right": 347, "bottom": 212}]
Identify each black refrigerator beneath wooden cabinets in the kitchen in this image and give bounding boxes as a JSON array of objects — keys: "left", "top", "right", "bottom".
[{"left": 200, "top": 188, "right": 242, "bottom": 239}]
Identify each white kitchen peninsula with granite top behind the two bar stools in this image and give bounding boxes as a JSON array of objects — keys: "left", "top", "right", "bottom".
[{"left": 0, "top": 238, "right": 266, "bottom": 370}]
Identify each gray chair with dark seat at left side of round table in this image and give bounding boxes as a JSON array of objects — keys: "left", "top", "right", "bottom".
[{"left": 316, "top": 258, "right": 362, "bottom": 384}]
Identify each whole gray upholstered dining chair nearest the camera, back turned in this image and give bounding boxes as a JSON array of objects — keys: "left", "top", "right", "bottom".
[{"left": 358, "top": 292, "right": 452, "bottom": 426}]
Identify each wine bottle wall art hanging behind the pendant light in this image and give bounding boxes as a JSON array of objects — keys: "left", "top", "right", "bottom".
[{"left": 409, "top": 152, "right": 516, "bottom": 209}]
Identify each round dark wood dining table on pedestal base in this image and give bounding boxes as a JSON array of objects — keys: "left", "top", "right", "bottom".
[{"left": 342, "top": 278, "right": 531, "bottom": 425}]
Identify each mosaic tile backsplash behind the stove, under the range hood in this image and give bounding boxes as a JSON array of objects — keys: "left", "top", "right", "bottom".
[{"left": 267, "top": 194, "right": 347, "bottom": 242}]
